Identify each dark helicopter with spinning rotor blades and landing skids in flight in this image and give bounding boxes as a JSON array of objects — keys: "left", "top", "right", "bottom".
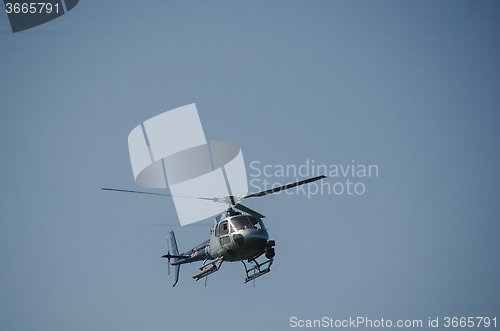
[{"left": 102, "top": 175, "right": 326, "bottom": 286}]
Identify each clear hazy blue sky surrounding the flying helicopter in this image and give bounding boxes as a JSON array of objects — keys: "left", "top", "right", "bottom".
[{"left": 0, "top": 0, "right": 500, "bottom": 330}]
